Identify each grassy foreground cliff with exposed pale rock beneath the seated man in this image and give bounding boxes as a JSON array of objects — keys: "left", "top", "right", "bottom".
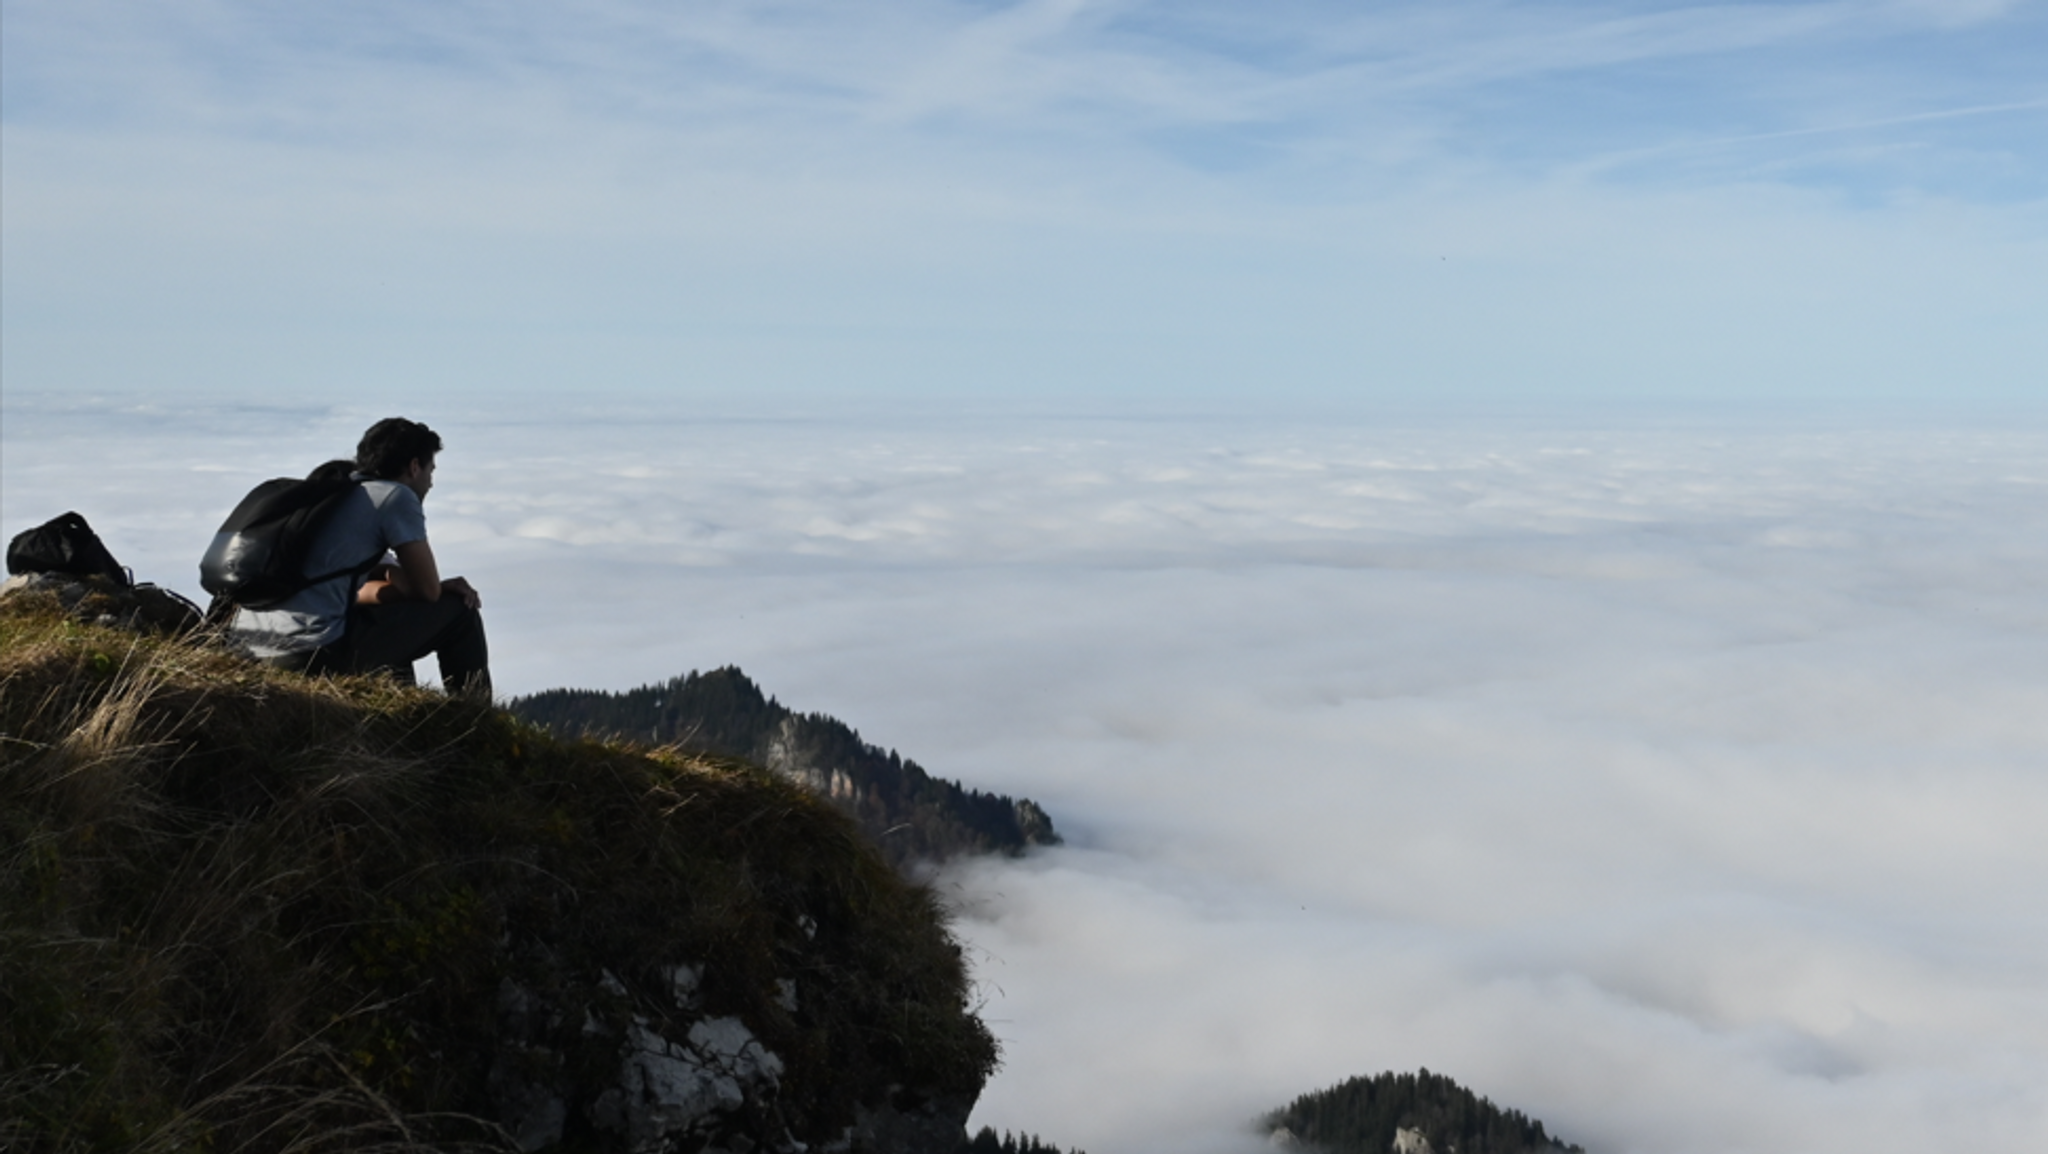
[{"left": 0, "top": 594, "right": 995, "bottom": 1154}]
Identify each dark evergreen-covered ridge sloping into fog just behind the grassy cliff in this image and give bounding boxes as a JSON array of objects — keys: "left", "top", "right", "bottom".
[{"left": 506, "top": 666, "right": 1059, "bottom": 869}]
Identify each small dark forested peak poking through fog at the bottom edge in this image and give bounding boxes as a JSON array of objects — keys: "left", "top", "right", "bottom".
[{"left": 1264, "top": 1070, "right": 1585, "bottom": 1154}]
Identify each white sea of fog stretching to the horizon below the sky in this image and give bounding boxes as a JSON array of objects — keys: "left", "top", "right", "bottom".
[{"left": 0, "top": 394, "right": 2048, "bottom": 1154}]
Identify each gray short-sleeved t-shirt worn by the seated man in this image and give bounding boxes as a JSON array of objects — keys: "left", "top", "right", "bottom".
[{"left": 233, "top": 480, "right": 426, "bottom": 658}]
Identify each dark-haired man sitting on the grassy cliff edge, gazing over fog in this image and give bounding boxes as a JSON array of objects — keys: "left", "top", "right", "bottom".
[{"left": 229, "top": 416, "right": 492, "bottom": 697}]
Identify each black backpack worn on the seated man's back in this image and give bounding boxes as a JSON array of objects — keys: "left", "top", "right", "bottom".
[{"left": 199, "top": 465, "right": 383, "bottom": 609}]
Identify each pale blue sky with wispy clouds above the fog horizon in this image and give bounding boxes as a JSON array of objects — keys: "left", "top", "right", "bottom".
[{"left": 0, "top": 0, "right": 2048, "bottom": 408}]
